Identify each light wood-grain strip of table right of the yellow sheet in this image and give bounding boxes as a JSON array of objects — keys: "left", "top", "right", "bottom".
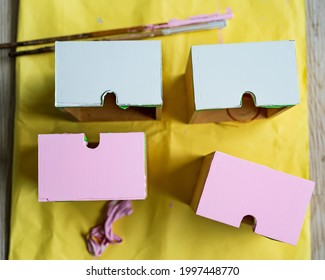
[{"left": 306, "top": 0, "right": 325, "bottom": 259}]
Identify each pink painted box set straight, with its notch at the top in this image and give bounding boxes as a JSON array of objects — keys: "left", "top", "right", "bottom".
[{"left": 38, "top": 132, "right": 146, "bottom": 201}]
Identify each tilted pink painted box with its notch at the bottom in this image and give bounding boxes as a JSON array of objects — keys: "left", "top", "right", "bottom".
[{"left": 192, "top": 152, "right": 315, "bottom": 245}]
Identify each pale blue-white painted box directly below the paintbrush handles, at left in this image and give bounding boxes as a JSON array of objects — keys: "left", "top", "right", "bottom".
[{"left": 55, "top": 41, "right": 162, "bottom": 121}]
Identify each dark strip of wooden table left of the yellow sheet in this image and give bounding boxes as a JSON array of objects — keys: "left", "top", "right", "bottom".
[{"left": 0, "top": 0, "right": 18, "bottom": 259}]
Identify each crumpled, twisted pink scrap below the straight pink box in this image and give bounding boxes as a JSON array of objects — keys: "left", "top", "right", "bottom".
[{"left": 86, "top": 200, "right": 133, "bottom": 256}]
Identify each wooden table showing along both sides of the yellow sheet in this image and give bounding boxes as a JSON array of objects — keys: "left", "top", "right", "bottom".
[{"left": 0, "top": 0, "right": 325, "bottom": 259}]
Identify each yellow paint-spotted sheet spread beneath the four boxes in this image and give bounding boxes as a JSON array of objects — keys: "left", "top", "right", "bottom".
[{"left": 10, "top": 0, "right": 310, "bottom": 259}]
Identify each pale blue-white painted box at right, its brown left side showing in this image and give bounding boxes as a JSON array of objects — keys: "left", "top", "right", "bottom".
[{"left": 185, "top": 41, "right": 299, "bottom": 123}]
